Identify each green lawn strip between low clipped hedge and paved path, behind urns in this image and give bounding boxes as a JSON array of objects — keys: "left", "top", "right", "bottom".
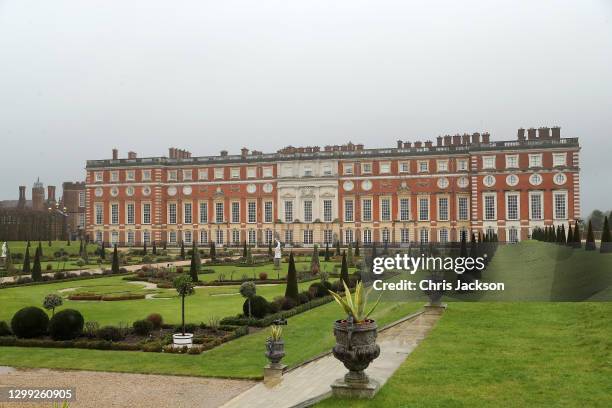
[{"left": 0, "top": 298, "right": 422, "bottom": 378}]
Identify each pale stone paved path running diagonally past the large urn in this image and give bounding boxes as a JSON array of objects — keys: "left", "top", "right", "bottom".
[{"left": 223, "top": 313, "right": 440, "bottom": 408}]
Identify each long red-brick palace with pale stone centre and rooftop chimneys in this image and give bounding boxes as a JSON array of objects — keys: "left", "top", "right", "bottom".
[{"left": 85, "top": 127, "right": 580, "bottom": 246}]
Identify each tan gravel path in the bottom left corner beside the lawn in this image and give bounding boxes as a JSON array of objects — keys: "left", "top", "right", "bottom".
[{"left": 0, "top": 367, "right": 255, "bottom": 408}]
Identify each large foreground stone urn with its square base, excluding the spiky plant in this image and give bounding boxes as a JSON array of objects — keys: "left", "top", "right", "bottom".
[{"left": 331, "top": 320, "right": 380, "bottom": 398}]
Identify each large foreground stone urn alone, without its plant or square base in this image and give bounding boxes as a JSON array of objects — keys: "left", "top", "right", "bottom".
[{"left": 332, "top": 320, "right": 380, "bottom": 387}]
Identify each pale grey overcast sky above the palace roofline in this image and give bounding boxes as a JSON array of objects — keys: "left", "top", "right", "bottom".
[{"left": 0, "top": 0, "right": 612, "bottom": 215}]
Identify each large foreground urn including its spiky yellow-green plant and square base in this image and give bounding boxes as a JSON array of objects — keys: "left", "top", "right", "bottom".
[{"left": 330, "top": 282, "right": 380, "bottom": 398}]
